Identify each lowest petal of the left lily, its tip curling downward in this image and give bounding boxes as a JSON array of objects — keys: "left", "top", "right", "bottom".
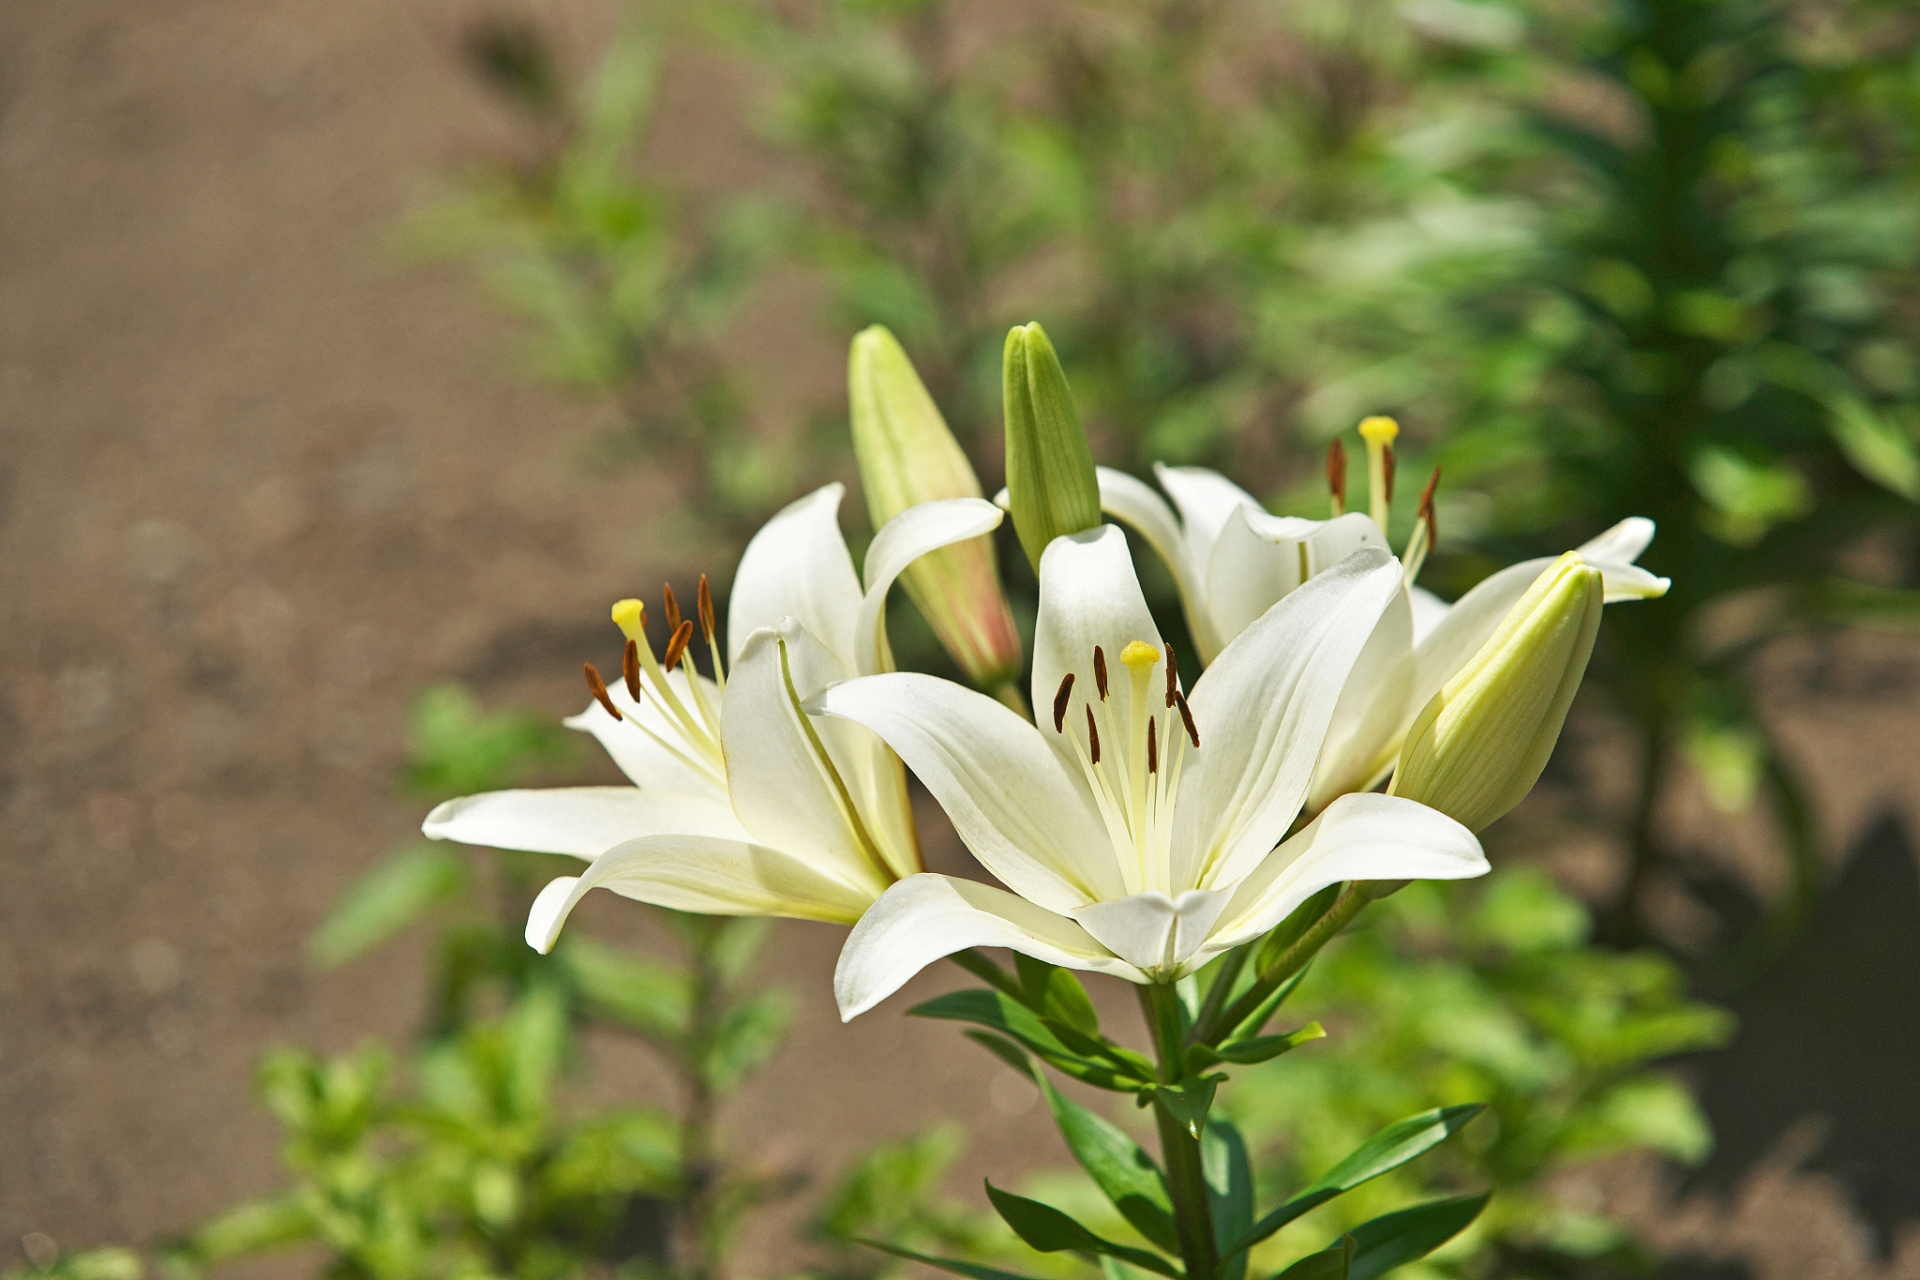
[{"left": 526, "top": 835, "right": 876, "bottom": 954}]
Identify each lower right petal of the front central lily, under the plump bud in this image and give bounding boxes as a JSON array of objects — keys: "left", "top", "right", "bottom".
[{"left": 1187, "top": 794, "right": 1490, "bottom": 969}]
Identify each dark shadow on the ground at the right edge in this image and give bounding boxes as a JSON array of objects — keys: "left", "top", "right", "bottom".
[{"left": 1665, "top": 812, "right": 1920, "bottom": 1276}]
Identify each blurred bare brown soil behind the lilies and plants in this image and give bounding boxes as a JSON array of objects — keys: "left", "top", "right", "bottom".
[{"left": 0, "top": 0, "right": 1920, "bottom": 1280}]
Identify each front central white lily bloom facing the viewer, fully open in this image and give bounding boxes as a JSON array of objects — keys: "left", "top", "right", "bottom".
[{"left": 810, "top": 526, "right": 1486, "bottom": 1017}]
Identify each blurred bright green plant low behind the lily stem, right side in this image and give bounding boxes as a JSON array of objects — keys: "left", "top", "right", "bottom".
[{"left": 1225, "top": 867, "right": 1732, "bottom": 1280}]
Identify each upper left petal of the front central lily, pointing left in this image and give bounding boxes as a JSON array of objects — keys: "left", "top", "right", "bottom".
[{"left": 810, "top": 671, "right": 1127, "bottom": 913}]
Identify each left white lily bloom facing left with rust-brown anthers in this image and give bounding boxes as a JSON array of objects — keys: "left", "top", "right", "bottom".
[{"left": 422, "top": 484, "right": 1000, "bottom": 952}]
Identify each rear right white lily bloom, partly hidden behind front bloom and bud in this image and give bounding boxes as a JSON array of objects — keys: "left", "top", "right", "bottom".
[{"left": 1098, "top": 466, "right": 1668, "bottom": 814}]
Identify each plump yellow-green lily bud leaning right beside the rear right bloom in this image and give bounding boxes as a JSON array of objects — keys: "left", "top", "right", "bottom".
[{"left": 1390, "top": 551, "right": 1605, "bottom": 831}]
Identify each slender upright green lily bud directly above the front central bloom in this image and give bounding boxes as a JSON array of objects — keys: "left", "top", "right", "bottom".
[{"left": 1002, "top": 324, "right": 1100, "bottom": 570}]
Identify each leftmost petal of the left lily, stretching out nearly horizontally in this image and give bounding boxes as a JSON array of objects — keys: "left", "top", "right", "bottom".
[{"left": 420, "top": 787, "right": 747, "bottom": 858}]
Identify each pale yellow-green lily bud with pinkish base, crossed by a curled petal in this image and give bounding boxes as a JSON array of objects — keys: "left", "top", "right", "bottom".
[{"left": 847, "top": 324, "right": 1020, "bottom": 689}]
